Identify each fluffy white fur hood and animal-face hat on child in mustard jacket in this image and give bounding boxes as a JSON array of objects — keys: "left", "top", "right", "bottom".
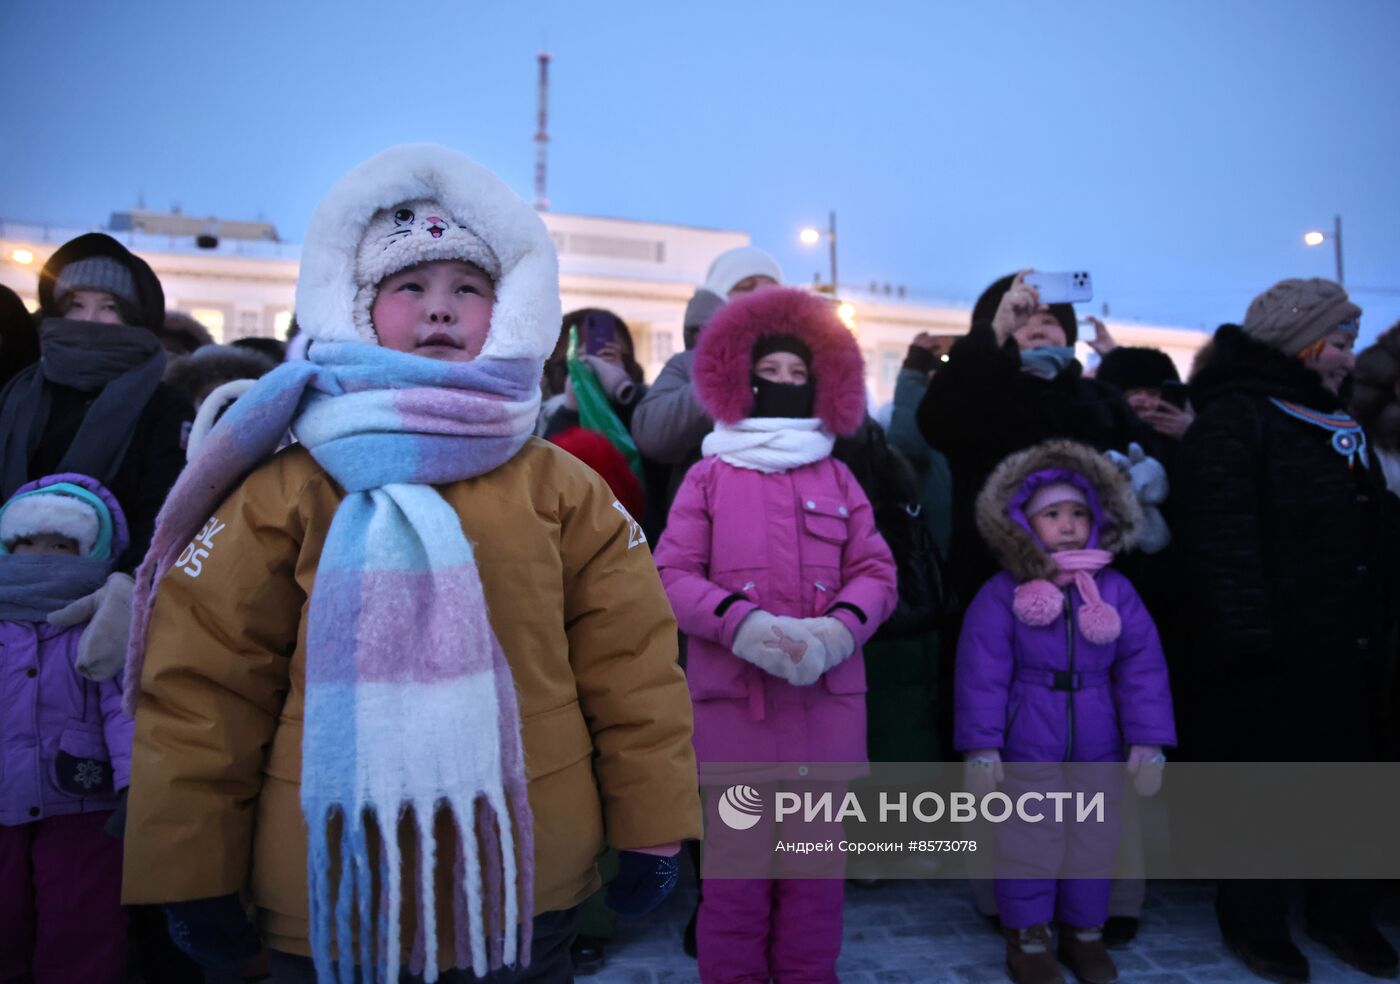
[{"left": 297, "top": 144, "right": 563, "bottom": 361}]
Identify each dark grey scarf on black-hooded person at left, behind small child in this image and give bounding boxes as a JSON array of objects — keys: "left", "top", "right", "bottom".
[{"left": 0, "top": 318, "right": 165, "bottom": 500}]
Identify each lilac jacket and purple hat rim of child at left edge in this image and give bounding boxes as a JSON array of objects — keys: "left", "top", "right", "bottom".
[{"left": 0, "top": 475, "right": 132, "bottom": 826}]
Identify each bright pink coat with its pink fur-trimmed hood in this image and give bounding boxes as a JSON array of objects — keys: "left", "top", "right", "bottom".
[{"left": 657, "top": 288, "right": 897, "bottom": 763}]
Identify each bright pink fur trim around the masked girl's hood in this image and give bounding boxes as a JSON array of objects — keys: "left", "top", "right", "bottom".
[{"left": 692, "top": 287, "right": 865, "bottom": 434}]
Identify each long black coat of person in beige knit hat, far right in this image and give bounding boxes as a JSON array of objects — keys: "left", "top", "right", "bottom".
[{"left": 1173, "top": 325, "right": 1397, "bottom": 761}]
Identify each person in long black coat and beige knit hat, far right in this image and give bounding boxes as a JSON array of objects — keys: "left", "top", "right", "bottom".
[{"left": 1175, "top": 279, "right": 1397, "bottom": 980}]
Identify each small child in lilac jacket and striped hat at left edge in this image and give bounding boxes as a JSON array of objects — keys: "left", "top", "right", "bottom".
[{"left": 0, "top": 475, "right": 132, "bottom": 984}]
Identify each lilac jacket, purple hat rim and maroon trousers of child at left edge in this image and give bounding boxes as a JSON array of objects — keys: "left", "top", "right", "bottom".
[{"left": 0, "top": 475, "right": 133, "bottom": 983}]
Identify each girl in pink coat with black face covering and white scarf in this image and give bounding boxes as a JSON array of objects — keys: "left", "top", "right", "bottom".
[{"left": 657, "top": 287, "right": 897, "bottom": 984}]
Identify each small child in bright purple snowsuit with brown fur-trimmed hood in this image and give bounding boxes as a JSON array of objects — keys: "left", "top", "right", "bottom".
[{"left": 953, "top": 441, "right": 1176, "bottom": 984}]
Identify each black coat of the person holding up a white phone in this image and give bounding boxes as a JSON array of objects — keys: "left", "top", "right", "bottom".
[{"left": 918, "top": 323, "right": 1151, "bottom": 599}]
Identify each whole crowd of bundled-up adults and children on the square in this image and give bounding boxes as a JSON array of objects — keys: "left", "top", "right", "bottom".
[{"left": 0, "top": 146, "right": 1400, "bottom": 984}]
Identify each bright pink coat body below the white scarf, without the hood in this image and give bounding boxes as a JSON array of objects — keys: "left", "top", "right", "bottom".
[{"left": 657, "top": 458, "right": 897, "bottom": 763}]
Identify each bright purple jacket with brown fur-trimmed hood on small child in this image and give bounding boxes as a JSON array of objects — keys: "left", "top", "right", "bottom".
[{"left": 953, "top": 441, "right": 1176, "bottom": 761}]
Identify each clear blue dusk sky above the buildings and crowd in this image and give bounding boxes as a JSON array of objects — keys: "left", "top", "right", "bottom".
[{"left": 0, "top": 0, "right": 1400, "bottom": 340}]
